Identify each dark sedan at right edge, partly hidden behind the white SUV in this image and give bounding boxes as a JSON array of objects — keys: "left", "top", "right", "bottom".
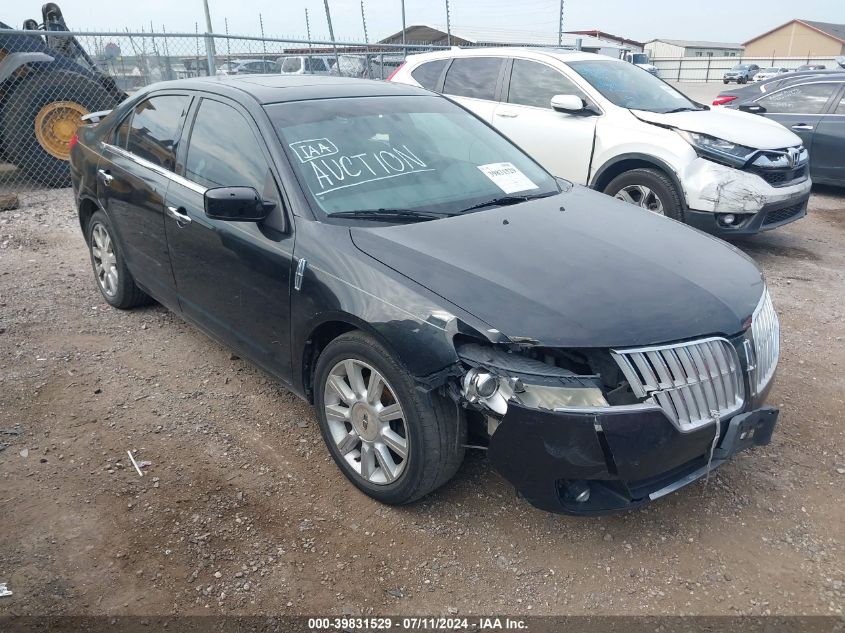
[{"left": 713, "top": 71, "right": 845, "bottom": 186}]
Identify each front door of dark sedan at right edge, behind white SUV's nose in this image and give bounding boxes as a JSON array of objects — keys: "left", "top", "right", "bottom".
[{"left": 754, "top": 81, "right": 839, "bottom": 158}]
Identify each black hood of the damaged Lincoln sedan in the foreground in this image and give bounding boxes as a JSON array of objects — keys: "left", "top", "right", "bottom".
[{"left": 350, "top": 187, "right": 763, "bottom": 347}]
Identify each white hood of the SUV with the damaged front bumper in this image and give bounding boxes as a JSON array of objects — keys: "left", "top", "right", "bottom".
[{"left": 631, "top": 108, "right": 801, "bottom": 149}]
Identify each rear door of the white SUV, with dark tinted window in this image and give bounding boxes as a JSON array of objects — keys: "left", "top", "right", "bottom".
[{"left": 441, "top": 57, "right": 505, "bottom": 123}]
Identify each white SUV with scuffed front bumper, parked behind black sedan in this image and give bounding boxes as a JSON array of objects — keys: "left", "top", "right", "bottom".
[{"left": 390, "top": 48, "right": 811, "bottom": 236}]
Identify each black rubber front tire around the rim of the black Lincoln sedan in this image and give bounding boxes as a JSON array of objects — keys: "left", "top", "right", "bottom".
[{"left": 314, "top": 331, "right": 466, "bottom": 505}]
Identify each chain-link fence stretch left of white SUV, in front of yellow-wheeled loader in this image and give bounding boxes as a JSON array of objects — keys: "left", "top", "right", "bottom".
[{"left": 0, "top": 28, "right": 443, "bottom": 194}]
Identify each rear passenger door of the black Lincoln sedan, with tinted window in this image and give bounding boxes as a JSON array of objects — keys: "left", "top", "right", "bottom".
[{"left": 97, "top": 94, "right": 190, "bottom": 309}]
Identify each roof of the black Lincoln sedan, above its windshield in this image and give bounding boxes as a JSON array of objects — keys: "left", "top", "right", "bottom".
[{"left": 149, "top": 74, "right": 432, "bottom": 104}]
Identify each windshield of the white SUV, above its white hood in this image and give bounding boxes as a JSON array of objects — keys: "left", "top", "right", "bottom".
[{"left": 568, "top": 61, "right": 701, "bottom": 112}]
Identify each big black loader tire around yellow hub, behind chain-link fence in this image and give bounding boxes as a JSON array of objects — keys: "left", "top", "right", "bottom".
[{"left": 0, "top": 71, "right": 117, "bottom": 187}]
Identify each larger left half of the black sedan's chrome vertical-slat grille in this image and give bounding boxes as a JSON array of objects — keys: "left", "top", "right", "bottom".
[{"left": 611, "top": 338, "right": 745, "bottom": 431}]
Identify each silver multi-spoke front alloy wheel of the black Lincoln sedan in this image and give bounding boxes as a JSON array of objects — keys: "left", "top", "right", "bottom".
[{"left": 323, "top": 358, "right": 409, "bottom": 485}]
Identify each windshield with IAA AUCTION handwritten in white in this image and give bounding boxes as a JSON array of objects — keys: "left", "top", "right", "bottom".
[{"left": 266, "top": 96, "right": 559, "bottom": 215}]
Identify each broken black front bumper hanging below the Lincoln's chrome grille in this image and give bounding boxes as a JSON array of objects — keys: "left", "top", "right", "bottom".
[{"left": 488, "top": 403, "right": 778, "bottom": 515}]
